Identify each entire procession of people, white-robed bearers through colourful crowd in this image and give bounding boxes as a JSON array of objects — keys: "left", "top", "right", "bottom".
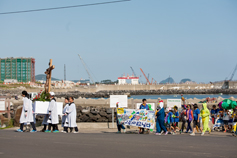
[{"left": 17, "top": 91, "right": 237, "bottom": 136}]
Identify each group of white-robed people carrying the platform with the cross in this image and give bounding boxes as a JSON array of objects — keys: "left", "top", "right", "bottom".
[{"left": 17, "top": 91, "right": 79, "bottom": 133}]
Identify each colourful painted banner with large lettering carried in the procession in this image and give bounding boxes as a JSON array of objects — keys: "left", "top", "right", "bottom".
[{"left": 117, "top": 108, "right": 155, "bottom": 129}]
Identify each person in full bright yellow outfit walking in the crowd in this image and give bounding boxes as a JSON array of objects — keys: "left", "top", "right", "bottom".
[{"left": 201, "top": 103, "right": 211, "bottom": 136}]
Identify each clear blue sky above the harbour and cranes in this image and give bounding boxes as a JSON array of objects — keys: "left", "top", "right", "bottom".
[{"left": 0, "top": 0, "right": 237, "bottom": 82}]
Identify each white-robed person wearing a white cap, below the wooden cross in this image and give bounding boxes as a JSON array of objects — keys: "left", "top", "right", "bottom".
[{"left": 45, "top": 92, "right": 59, "bottom": 133}]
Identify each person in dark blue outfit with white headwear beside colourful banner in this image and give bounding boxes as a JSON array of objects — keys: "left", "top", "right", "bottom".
[{"left": 156, "top": 102, "right": 168, "bottom": 135}]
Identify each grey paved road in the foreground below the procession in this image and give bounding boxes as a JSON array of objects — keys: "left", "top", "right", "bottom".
[{"left": 0, "top": 130, "right": 237, "bottom": 158}]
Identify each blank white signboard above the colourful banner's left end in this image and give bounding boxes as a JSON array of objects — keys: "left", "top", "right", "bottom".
[{"left": 110, "top": 95, "right": 128, "bottom": 108}]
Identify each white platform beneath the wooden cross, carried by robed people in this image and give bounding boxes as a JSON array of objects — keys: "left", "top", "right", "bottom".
[{"left": 33, "top": 101, "right": 63, "bottom": 115}]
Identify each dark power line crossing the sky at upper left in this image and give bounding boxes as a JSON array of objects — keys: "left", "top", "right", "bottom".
[{"left": 0, "top": 0, "right": 131, "bottom": 15}]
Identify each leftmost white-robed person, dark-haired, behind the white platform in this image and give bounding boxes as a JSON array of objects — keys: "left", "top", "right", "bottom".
[{"left": 17, "top": 91, "right": 37, "bottom": 133}]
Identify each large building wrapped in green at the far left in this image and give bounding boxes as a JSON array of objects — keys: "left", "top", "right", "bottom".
[{"left": 0, "top": 57, "right": 35, "bottom": 82}]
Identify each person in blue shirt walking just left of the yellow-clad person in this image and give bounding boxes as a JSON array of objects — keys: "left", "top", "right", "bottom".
[{"left": 190, "top": 104, "right": 202, "bottom": 136}]
